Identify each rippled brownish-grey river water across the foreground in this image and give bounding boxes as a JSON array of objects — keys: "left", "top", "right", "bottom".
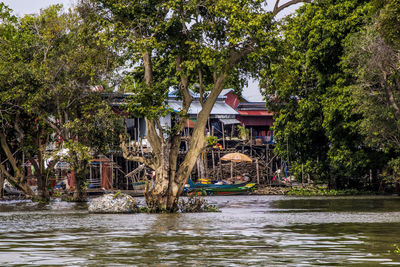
[{"left": 0, "top": 196, "right": 400, "bottom": 266}]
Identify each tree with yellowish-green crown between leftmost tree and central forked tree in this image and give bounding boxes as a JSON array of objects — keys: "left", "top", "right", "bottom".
[{"left": 21, "top": 5, "right": 120, "bottom": 201}]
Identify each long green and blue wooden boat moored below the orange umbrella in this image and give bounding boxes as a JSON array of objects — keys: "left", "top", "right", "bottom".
[{"left": 188, "top": 183, "right": 256, "bottom": 196}]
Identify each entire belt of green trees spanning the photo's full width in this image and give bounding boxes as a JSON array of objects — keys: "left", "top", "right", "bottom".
[{"left": 0, "top": 0, "right": 400, "bottom": 210}]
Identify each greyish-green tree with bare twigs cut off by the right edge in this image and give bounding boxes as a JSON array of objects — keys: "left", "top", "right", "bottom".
[{"left": 344, "top": 0, "right": 400, "bottom": 183}]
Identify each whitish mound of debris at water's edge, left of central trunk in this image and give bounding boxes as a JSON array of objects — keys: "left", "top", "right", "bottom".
[{"left": 88, "top": 192, "right": 138, "bottom": 213}]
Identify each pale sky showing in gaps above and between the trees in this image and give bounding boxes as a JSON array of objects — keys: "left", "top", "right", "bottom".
[{"left": 0, "top": 0, "right": 300, "bottom": 101}]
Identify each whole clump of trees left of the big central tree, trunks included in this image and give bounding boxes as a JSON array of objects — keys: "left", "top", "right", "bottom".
[{"left": 0, "top": 5, "right": 121, "bottom": 200}]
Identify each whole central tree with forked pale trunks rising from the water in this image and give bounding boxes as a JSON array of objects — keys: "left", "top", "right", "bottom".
[{"left": 81, "top": 0, "right": 311, "bottom": 211}]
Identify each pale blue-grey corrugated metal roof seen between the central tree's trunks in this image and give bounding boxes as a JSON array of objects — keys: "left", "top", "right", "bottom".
[{"left": 168, "top": 100, "right": 239, "bottom": 115}]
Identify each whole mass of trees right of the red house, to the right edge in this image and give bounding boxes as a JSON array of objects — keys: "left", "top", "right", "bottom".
[{"left": 262, "top": 0, "right": 400, "bottom": 190}]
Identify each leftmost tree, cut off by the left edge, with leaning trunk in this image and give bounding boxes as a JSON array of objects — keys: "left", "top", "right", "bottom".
[{"left": 0, "top": 4, "right": 49, "bottom": 200}]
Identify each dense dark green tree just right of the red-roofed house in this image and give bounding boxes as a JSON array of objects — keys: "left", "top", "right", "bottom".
[{"left": 262, "top": 0, "right": 373, "bottom": 187}]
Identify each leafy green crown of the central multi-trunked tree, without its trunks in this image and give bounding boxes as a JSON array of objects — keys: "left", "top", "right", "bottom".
[{"left": 81, "top": 0, "right": 276, "bottom": 118}]
